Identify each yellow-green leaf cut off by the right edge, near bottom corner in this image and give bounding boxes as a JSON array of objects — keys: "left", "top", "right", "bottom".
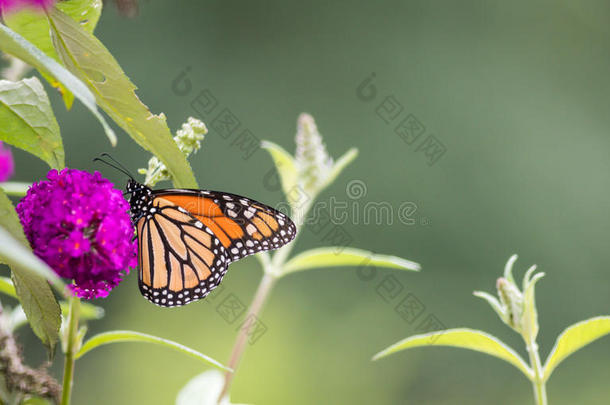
[{"left": 544, "top": 316, "right": 610, "bottom": 381}]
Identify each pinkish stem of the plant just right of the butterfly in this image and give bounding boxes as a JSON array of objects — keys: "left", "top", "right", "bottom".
[{"left": 218, "top": 271, "right": 277, "bottom": 403}]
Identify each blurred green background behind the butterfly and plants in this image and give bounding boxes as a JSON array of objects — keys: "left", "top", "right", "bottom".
[{"left": 4, "top": 0, "right": 610, "bottom": 405}]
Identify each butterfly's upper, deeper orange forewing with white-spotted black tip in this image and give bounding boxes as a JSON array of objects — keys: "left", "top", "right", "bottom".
[{"left": 153, "top": 190, "right": 296, "bottom": 261}]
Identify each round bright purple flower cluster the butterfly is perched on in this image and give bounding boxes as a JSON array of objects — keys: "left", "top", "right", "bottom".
[{"left": 17, "top": 169, "right": 137, "bottom": 299}]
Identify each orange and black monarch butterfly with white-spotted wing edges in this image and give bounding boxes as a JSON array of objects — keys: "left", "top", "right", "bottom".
[{"left": 95, "top": 154, "right": 296, "bottom": 307}]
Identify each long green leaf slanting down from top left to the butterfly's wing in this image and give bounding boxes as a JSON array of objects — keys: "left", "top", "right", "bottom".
[{"left": 48, "top": 10, "right": 197, "bottom": 188}]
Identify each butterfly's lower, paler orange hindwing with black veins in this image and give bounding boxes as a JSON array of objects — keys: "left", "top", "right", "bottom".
[{"left": 137, "top": 197, "right": 231, "bottom": 307}]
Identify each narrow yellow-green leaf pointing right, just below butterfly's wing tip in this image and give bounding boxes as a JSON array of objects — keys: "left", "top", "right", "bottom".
[{"left": 281, "top": 247, "right": 421, "bottom": 276}]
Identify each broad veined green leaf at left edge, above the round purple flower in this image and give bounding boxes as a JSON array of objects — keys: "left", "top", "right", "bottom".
[{"left": 0, "top": 77, "right": 65, "bottom": 169}]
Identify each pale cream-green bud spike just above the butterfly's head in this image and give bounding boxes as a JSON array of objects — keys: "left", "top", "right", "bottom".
[{"left": 138, "top": 117, "right": 208, "bottom": 187}]
